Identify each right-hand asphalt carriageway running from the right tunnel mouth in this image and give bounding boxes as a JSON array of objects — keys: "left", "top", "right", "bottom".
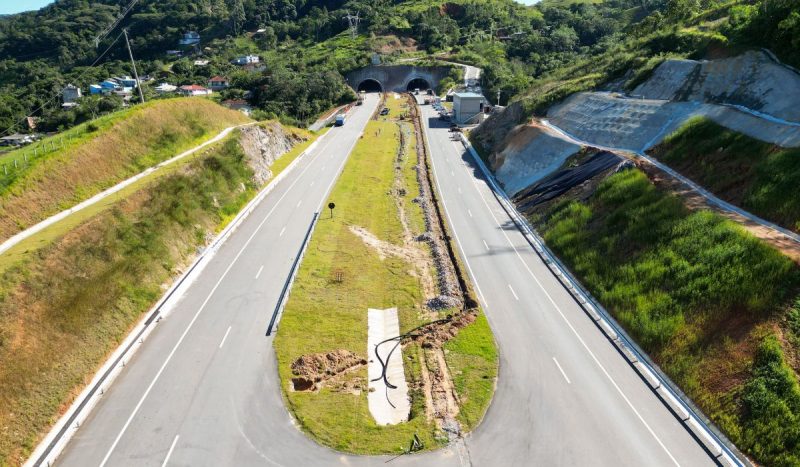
[{"left": 422, "top": 101, "right": 714, "bottom": 466}]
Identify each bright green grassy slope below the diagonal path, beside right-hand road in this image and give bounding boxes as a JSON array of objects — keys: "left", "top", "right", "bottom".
[{"left": 538, "top": 170, "right": 800, "bottom": 463}]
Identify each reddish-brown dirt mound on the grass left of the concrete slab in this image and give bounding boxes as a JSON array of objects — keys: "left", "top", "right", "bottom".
[{"left": 292, "top": 349, "right": 367, "bottom": 392}]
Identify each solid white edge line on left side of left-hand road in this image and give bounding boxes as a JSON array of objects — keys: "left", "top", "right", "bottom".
[{"left": 95, "top": 100, "right": 374, "bottom": 467}]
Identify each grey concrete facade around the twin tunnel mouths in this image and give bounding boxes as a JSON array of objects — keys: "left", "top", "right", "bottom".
[{"left": 345, "top": 65, "right": 451, "bottom": 92}]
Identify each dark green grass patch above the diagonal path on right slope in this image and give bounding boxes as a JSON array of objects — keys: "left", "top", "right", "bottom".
[{"left": 651, "top": 118, "right": 800, "bottom": 231}]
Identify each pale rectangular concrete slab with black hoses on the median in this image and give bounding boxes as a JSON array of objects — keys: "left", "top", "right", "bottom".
[{"left": 367, "top": 308, "right": 411, "bottom": 425}]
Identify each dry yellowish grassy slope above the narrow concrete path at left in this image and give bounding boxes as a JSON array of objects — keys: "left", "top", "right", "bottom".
[{"left": 0, "top": 98, "right": 249, "bottom": 245}]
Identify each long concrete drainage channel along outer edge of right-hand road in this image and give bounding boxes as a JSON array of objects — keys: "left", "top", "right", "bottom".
[{"left": 460, "top": 134, "right": 752, "bottom": 467}]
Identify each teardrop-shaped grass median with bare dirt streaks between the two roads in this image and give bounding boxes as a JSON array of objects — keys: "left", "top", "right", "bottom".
[{"left": 274, "top": 95, "right": 497, "bottom": 454}]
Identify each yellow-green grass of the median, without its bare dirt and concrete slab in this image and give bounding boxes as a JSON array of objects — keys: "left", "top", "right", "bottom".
[{"left": 275, "top": 95, "right": 496, "bottom": 453}]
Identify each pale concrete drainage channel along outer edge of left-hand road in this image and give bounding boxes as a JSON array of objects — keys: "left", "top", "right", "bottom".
[{"left": 24, "top": 129, "right": 328, "bottom": 467}]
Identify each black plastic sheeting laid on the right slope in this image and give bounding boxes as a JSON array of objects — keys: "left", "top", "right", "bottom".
[{"left": 514, "top": 151, "right": 625, "bottom": 212}]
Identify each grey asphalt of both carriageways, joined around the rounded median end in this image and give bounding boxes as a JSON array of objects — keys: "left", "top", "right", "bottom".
[{"left": 59, "top": 95, "right": 711, "bottom": 467}]
